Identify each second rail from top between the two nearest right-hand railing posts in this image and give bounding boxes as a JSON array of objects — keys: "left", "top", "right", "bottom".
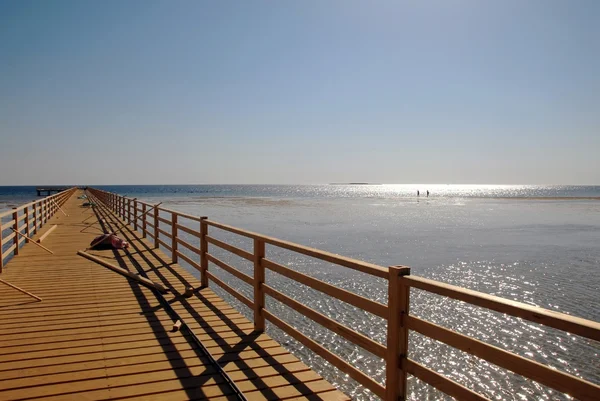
[{"left": 263, "top": 259, "right": 388, "bottom": 318}]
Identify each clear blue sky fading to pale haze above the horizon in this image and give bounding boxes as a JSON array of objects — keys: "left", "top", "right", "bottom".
[{"left": 0, "top": 0, "right": 600, "bottom": 185}]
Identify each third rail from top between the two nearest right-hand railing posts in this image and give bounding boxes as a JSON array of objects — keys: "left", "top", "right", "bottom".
[{"left": 263, "top": 284, "right": 386, "bottom": 358}]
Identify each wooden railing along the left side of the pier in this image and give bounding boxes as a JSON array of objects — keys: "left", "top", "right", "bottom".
[{"left": 0, "top": 188, "right": 76, "bottom": 273}]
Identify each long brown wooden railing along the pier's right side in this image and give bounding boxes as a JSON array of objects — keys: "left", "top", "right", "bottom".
[{"left": 85, "top": 189, "right": 600, "bottom": 401}]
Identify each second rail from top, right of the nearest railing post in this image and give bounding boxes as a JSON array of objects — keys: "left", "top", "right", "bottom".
[{"left": 407, "top": 316, "right": 600, "bottom": 401}]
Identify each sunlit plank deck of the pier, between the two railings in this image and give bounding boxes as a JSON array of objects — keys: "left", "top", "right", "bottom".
[{"left": 0, "top": 191, "right": 348, "bottom": 400}]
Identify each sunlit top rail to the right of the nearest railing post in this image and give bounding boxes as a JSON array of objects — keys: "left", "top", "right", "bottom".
[{"left": 406, "top": 276, "right": 600, "bottom": 341}]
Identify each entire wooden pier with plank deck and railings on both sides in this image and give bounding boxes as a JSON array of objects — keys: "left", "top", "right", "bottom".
[{"left": 0, "top": 189, "right": 600, "bottom": 401}]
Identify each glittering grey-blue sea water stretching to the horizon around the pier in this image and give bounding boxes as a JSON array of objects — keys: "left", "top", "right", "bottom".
[{"left": 0, "top": 185, "right": 600, "bottom": 400}]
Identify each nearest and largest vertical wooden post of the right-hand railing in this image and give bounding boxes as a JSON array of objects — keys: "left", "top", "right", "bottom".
[{"left": 385, "top": 266, "right": 410, "bottom": 401}]
